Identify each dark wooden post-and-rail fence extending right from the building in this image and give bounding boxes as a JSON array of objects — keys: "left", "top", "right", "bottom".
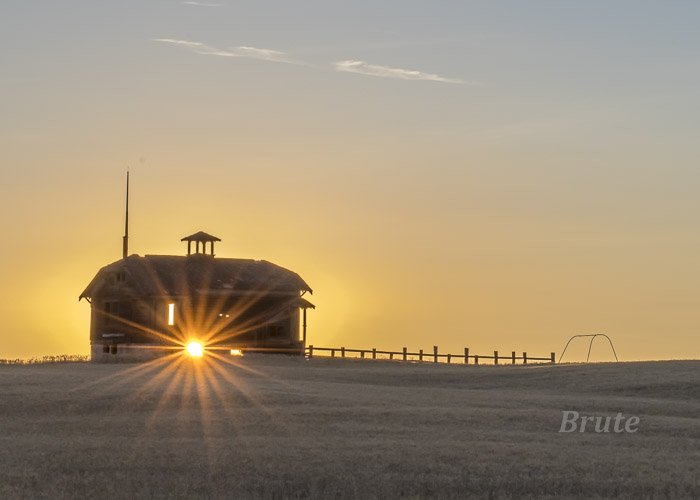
[{"left": 306, "top": 345, "right": 555, "bottom": 365}]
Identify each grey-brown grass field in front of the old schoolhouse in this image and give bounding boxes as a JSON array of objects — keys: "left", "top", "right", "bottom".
[{"left": 0, "top": 356, "right": 700, "bottom": 498}]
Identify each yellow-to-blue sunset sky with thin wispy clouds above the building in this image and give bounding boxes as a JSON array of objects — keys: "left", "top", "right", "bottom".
[{"left": 0, "top": 0, "right": 700, "bottom": 361}]
